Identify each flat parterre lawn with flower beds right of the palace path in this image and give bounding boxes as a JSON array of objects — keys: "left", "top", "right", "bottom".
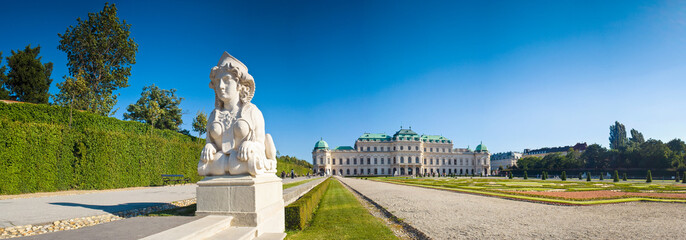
[{"left": 369, "top": 177, "right": 686, "bottom": 205}]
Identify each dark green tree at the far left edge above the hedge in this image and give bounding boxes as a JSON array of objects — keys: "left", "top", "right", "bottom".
[{"left": 0, "top": 44, "right": 52, "bottom": 104}]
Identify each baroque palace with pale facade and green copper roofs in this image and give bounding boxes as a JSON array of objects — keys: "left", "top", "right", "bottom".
[{"left": 312, "top": 127, "right": 491, "bottom": 176}]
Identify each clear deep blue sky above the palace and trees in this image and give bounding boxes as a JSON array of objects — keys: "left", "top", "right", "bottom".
[{"left": 0, "top": 0, "right": 686, "bottom": 160}]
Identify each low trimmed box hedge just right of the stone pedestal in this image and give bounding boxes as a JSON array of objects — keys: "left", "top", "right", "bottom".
[{"left": 285, "top": 179, "right": 331, "bottom": 230}]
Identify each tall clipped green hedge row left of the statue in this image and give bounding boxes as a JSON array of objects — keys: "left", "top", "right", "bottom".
[{"left": 0, "top": 102, "right": 204, "bottom": 194}]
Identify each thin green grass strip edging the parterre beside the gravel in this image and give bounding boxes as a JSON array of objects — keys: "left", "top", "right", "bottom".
[{"left": 372, "top": 179, "right": 686, "bottom": 205}]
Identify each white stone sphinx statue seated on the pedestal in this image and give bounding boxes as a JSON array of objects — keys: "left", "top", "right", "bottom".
[{"left": 198, "top": 52, "right": 276, "bottom": 176}]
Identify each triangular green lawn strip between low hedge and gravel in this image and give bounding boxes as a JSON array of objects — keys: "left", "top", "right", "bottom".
[{"left": 286, "top": 179, "right": 397, "bottom": 239}]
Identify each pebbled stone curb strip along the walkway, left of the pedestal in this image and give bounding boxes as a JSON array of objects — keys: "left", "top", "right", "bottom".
[{"left": 0, "top": 198, "right": 196, "bottom": 239}]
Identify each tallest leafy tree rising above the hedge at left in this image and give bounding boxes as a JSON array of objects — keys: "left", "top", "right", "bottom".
[{"left": 57, "top": 3, "right": 138, "bottom": 116}]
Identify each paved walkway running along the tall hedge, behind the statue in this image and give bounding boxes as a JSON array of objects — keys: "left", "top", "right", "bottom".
[{"left": 0, "top": 177, "right": 318, "bottom": 228}]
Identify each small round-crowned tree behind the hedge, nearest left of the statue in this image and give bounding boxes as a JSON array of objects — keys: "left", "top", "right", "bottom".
[{"left": 124, "top": 84, "right": 183, "bottom": 131}]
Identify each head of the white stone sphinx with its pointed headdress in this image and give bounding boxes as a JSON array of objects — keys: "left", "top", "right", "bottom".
[{"left": 209, "top": 52, "right": 255, "bottom": 109}]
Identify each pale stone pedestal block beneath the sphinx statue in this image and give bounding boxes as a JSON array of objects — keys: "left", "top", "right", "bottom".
[{"left": 195, "top": 174, "right": 285, "bottom": 235}]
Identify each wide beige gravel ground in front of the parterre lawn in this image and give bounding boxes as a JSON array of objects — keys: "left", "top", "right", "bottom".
[{"left": 341, "top": 178, "right": 686, "bottom": 239}]
